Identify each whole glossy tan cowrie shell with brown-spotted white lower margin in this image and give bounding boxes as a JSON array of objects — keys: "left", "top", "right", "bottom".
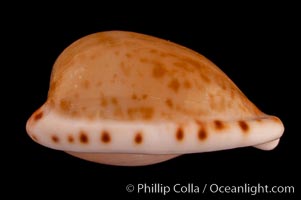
[{"left": 26, "top": 31, "right": 284, "bottom": 166}]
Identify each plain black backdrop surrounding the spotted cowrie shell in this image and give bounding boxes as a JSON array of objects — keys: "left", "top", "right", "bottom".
[{"left": 1, "top": 3, "right": 300, "bottom": 199}]
